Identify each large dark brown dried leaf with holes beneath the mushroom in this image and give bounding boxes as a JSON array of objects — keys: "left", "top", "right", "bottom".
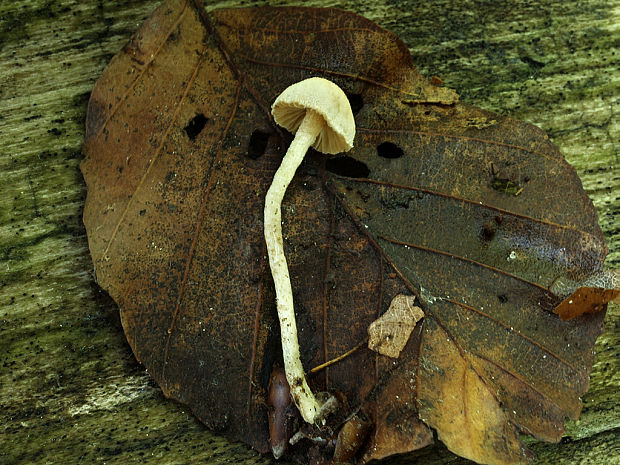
[{"left": 82, "top": 0, "right": 607, "bottom": 464}]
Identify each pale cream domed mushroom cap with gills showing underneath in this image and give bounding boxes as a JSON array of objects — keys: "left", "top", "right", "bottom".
[{"left": 271, "top": 77, "right": 355, "bottom": 154}]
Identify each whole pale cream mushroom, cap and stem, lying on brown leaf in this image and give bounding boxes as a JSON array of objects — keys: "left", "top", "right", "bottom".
[{"left": 265, "top": 77, "right": 355, "bottom": 424}]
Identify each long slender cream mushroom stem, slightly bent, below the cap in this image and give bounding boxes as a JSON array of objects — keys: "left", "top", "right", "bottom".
[{"left": 264, "top": 109, "right": 324, "bottom": 423}]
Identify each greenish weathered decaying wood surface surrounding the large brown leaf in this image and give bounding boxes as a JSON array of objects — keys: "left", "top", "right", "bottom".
[{"left": 0, "top": 0, "right": 620, "bottom": 464}]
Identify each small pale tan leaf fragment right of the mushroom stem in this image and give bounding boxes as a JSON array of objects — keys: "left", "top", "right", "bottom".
[{"left": 368, "top": 294, "right": 424, "bottom": 358}]
